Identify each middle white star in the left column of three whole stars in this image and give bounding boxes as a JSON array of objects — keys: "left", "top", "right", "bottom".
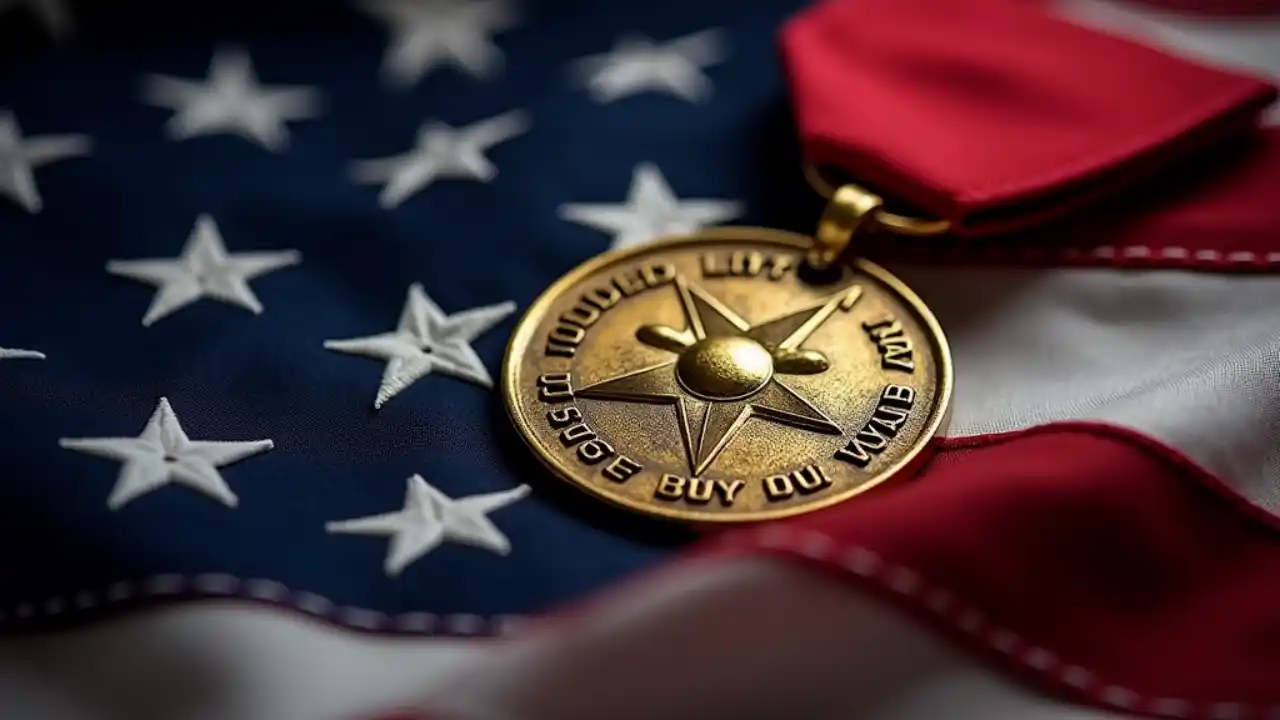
[{"left": 106, "top": 215, "right": 302, "bottom": 327}]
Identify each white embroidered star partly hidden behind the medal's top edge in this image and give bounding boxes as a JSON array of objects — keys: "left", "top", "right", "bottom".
[{"left": 559, "top": 163, "right": 742, "bottom": 249}]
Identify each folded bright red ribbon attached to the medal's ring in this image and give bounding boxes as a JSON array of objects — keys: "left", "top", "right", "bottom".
[{"left": 782, "top": 0, "right": 1276, "bottom": 237}]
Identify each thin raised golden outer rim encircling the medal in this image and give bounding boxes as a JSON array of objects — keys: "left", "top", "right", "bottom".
[{"left": 500, "top": 225, "right": 955, "bottom": 527}]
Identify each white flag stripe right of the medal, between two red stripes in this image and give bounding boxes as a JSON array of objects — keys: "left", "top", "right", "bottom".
[{"left": 895, "top": 268, "right": 1280, "bottom": 511}]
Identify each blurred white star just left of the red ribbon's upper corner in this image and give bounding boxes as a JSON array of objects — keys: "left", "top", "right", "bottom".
[{"left": 571, "top": 28, "right": 724, "bottom": 102}]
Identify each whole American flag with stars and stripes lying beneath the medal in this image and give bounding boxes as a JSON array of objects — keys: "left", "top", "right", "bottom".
[{"left": 0, "top": 0, "right": 1280, "bottom": 720}]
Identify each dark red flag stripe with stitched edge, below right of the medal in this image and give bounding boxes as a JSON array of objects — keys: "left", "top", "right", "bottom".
[{"left": 704, "top": 424, "right": 1280, "bottom": 717}]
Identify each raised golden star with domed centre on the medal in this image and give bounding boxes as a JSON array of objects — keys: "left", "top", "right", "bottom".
[{"left": 576, "top": 277, "right": 863, "bottom": 477}]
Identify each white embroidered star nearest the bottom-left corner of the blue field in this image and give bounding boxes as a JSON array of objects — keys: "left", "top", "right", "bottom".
[{"left": 58, "top": 397, "right": 274, "bottom": 510}]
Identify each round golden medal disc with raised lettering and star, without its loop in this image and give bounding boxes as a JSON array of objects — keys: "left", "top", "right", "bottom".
[{"left": 503, "top": 228, "right": 951, "bottom": 523}]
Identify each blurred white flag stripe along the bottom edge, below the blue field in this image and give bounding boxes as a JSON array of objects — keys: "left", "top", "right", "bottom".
[{"left": 0, "top": 560, "right": 1111, "bottom": 720}]
